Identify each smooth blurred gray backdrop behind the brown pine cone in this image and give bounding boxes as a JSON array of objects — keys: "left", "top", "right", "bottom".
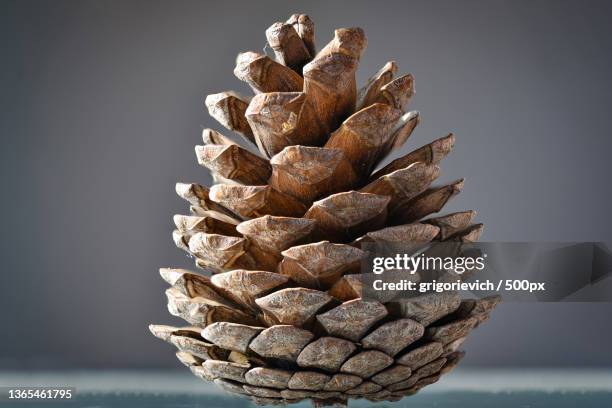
[{"left": 0, "top": 1, "right": 612, "bottom": 369}]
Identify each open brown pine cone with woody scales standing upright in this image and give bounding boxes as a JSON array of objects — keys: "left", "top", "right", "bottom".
[{"left": 150, "top": 15, "right": 499, "bottom": 406}]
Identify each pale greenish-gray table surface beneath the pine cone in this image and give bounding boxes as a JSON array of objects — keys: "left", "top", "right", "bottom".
[{"left": 0, "top": 369, "right": 612, "bottom": 408}]
